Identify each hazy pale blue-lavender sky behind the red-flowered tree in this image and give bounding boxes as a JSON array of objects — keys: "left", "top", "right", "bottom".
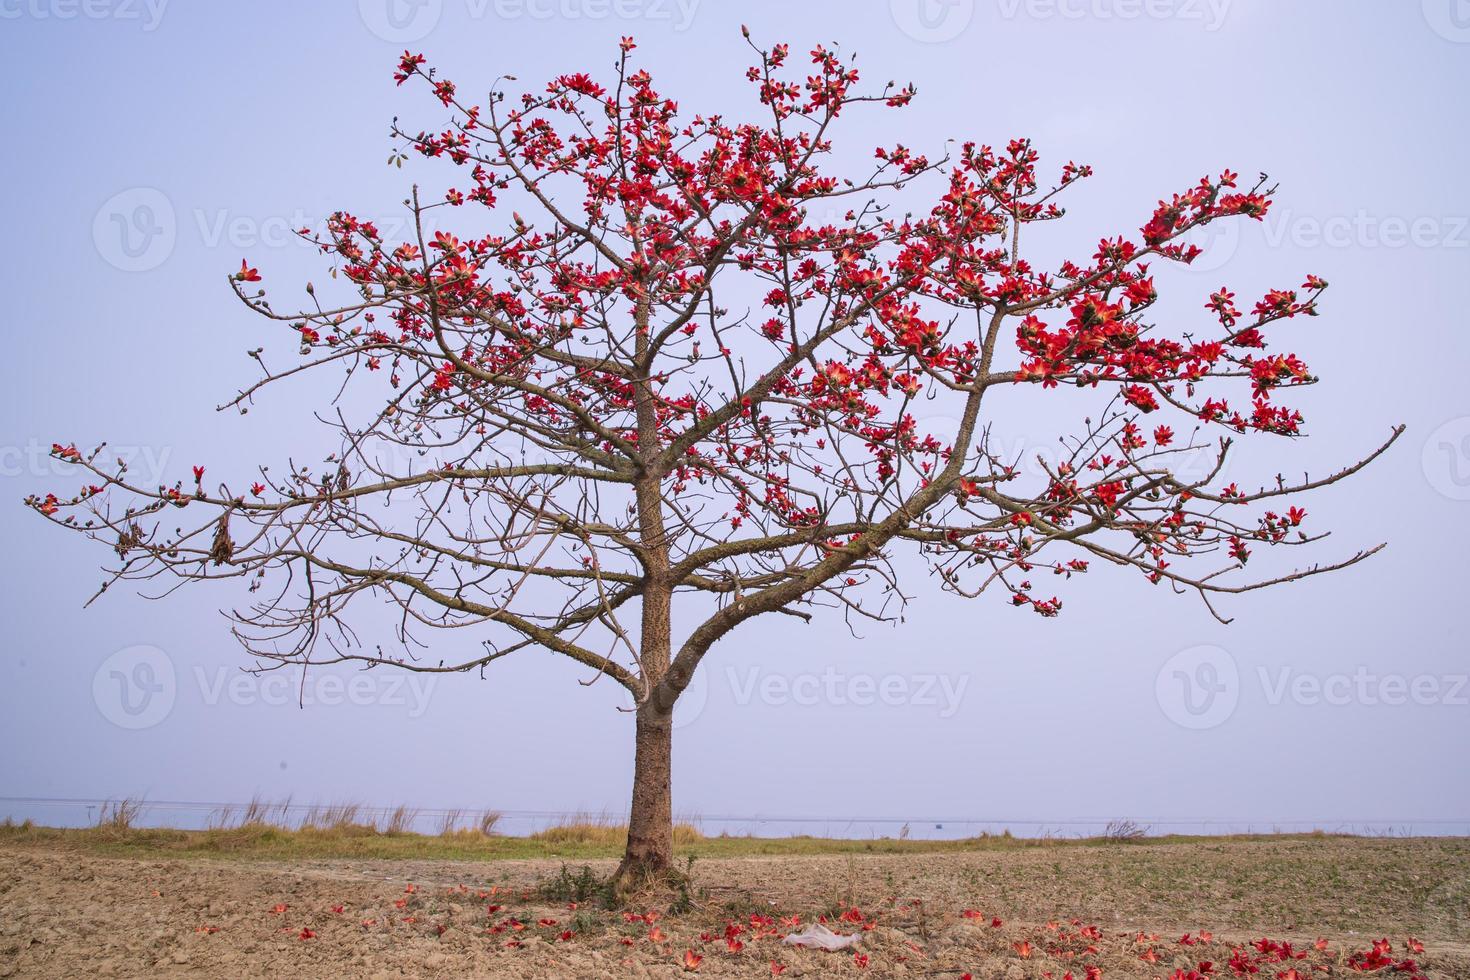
[{"left": 0, "top": 0, "right": 1470, "bottom": 835}]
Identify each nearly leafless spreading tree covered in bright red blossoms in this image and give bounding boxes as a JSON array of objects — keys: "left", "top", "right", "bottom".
[{"left": 28, "top": 35, "right": 1402, "bottom": 882}]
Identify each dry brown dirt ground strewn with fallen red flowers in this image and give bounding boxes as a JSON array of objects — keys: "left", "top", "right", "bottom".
[{"left": 0, "top": 837, "right": 1470, "bottom": 980}]
